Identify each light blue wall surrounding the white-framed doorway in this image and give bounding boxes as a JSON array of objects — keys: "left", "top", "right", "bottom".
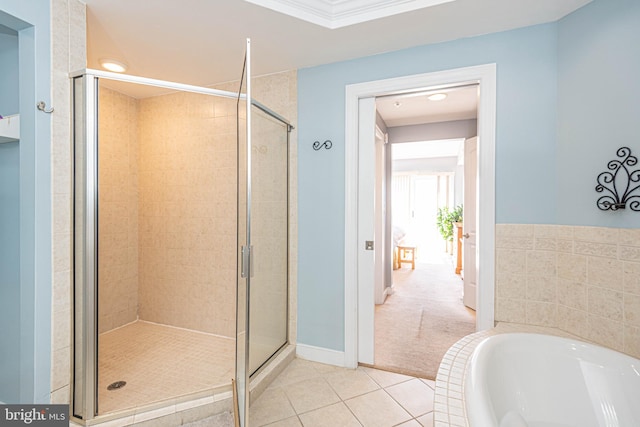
[{"left": 298, "top": 24, "right": 557, "bottom": 351}]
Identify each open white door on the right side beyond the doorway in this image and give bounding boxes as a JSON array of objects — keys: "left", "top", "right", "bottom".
[{"left": 462, "top": 137, "right": 478, "bottom": 310}]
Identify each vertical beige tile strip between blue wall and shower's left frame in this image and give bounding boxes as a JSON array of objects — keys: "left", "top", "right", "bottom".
[{"left": 50, "top": 0, "right": 87, "bottom": 404}]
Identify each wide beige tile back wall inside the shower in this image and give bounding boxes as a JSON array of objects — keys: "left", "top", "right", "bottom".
[{"left": 139, "top": 93, "right": 237, "bottom": 337}]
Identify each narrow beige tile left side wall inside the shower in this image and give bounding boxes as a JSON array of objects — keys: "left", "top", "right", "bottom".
[{"left": 98, "top": 87, "right": 138, "bottom": 333}]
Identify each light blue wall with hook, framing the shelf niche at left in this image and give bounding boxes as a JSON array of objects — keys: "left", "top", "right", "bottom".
[{"left": 0, "top": 0, "right": 52, "bottom": 403}]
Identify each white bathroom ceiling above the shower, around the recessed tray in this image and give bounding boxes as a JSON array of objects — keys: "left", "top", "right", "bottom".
[{"left": 85, "top": 0, "right": 590, "bottom": 96}]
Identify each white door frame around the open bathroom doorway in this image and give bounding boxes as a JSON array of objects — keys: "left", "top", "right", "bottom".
[{"left": 344, "top": 64, "right": 496, "bottom": 368}]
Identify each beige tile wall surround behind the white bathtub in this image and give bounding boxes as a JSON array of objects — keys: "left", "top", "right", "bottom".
[{"left": 495, "top": 224, "right": 640, "bottom": 357}]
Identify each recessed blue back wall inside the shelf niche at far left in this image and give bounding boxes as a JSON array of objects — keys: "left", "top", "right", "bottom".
[{"left": 0, "top": 28, "right": 20, "bottom": 402}]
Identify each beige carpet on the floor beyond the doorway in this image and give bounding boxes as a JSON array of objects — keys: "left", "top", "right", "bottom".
[{"left": 374, "top": 254, "right": 476, "bottom": 379}]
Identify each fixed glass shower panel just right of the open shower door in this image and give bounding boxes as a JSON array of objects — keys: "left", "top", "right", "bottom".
[{"left": 249, "top": 105, "right": 289, "bottom": 374}]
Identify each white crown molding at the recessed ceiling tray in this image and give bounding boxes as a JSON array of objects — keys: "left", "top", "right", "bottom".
[{"left": 245, "top": 0, "right": 455, "bottom": 29}]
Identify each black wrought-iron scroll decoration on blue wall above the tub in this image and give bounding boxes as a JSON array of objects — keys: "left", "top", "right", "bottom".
[{"left": 596, "top": 147, "right": 640, "bottom": 212}]
